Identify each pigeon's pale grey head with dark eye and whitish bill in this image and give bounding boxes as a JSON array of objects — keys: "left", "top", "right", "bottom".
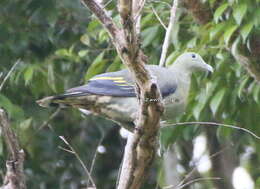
[{"left": 172, "top": 52, "right": 213, "bottom": 73}]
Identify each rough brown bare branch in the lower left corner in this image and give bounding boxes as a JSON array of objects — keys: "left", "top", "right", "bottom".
[{"left": 0, "top": 108, "right": 26, "bottom": 189}]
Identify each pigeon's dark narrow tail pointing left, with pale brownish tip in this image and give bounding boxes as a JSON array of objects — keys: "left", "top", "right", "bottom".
[{"left": 36, "top": 93, "right": 88, "bottom": 108}]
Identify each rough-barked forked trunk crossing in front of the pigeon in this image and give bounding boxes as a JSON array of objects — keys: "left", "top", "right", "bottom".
[{"left": 80, "top": 0, "right": 163, "bottom": 189}]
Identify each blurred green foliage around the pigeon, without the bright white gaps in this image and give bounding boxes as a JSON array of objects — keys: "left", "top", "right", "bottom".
[{"left": 0, "top": 0, "right": 260, "bottom": 189}]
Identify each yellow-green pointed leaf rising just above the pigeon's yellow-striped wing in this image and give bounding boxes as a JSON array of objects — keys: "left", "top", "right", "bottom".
[{"left": 85, "top": 52, "right": 107, "bottom": 81}]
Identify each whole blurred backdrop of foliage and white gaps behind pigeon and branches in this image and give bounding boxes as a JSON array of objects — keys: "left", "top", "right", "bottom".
[{"left": 0, "top": 0, "right": 260, "bottom": 189}]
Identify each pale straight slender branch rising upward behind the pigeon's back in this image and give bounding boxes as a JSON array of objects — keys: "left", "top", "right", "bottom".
[{"left": 159, "top": 0, "right": 178, "bottom": 67}]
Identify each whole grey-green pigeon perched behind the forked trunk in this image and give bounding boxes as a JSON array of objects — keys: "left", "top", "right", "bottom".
[{"left": 37, "top": 52, "right": 213, "bottom": 130}]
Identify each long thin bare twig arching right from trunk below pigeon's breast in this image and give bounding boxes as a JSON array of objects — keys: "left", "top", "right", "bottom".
[{"left": 161, "top": 122, "right": 260, "bottom": 140}]
